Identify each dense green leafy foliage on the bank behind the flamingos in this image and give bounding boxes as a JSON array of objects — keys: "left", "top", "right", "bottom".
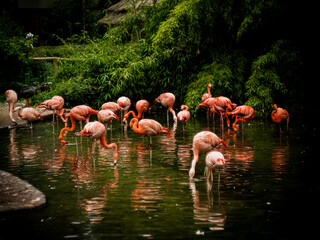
[{"left": 0, "top": 0, "right": 312, "bottom": 117}]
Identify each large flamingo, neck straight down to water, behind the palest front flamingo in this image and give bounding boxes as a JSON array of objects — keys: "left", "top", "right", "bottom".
[{"left": 189, "top": 131, "right": 228, "bottom": 179}]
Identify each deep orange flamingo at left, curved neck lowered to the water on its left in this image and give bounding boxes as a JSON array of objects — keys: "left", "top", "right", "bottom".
[{"left": 59, "top": 105, "right": 99, "bottom": 143}]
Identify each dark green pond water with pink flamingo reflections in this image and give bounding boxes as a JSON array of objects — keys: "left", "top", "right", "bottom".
[{"left": 0, "top": 115, "right": 319, "bottom": 239}]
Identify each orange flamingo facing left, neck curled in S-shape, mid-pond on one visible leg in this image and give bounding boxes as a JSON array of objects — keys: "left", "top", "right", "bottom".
[{"left": 130, "top": 118, "right": 169, "bottom": 150}]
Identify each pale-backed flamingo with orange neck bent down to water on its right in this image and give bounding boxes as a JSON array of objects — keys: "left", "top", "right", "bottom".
[{"left": 80, "top": 121, "right": 118, "bottom": 165}]
